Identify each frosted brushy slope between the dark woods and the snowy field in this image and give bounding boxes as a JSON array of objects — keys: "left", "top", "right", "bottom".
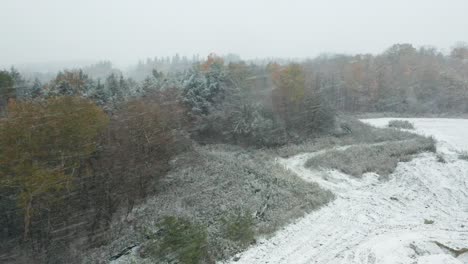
[{"left": 91, "top": 145, "right": 334, "bottom": 263}]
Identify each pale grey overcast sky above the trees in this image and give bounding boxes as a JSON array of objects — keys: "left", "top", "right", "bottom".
[{"left": 0, "top": 0, "right": 468, "bottom": 67}]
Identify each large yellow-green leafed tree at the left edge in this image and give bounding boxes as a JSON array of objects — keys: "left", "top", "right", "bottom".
[{"left": 0, "top": 97, "right": 108, "bottom": 239}]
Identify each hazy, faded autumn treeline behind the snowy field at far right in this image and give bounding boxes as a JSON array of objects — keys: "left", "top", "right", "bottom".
[{"left": 304, "top": 44, "right": 468, "bottom": 114}]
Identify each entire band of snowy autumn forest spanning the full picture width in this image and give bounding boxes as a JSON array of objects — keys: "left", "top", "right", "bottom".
[{"left": 0, "top": 41, "right": 468, "bottom": 263}]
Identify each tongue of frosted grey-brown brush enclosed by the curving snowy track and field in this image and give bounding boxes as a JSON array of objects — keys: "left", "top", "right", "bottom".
[{"left": 306, "top": 137, "right": 435, "bottom": 177}]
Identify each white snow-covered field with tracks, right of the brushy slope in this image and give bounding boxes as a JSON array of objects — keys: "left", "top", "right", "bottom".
[{"left": 232, "top": 118, "right": 468, "bottom": 264}]
